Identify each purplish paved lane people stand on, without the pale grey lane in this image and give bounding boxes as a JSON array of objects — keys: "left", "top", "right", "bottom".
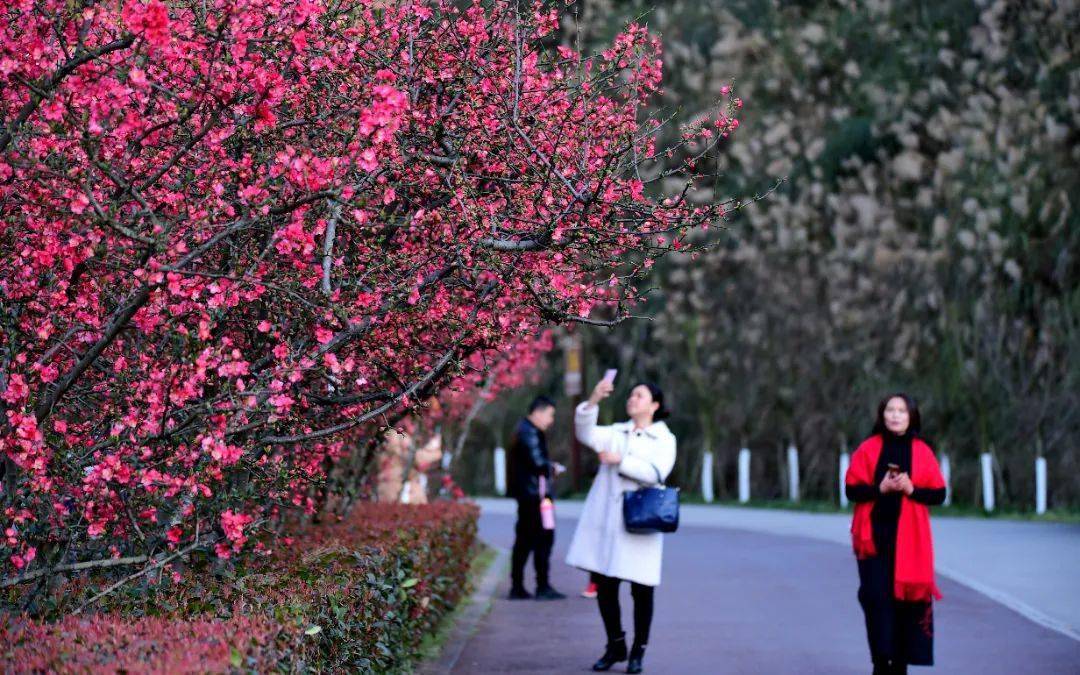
[{"left": 454, "top": 502, "right": 1080, "bottom": 675}]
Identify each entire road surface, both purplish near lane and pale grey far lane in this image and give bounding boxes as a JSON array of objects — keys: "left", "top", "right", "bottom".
[{"left": 454, "top": 500, "right": 1080, "bottom": 675}]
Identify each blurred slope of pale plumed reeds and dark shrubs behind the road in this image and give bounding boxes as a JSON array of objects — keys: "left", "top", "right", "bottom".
[{"left": 451, "top": 0, "right": 1080, "bottom": 507}]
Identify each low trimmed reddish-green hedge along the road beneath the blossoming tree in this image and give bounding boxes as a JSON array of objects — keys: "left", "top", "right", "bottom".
[{"left": 0, "top": 502, "right": 477, "bottom": 673}]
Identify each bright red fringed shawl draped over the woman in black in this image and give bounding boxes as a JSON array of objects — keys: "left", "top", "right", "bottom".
[{"left": 843, "top": 435, "right": 945, "bottom": 602}]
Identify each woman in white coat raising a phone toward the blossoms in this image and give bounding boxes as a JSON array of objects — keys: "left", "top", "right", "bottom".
[{"left": 566, "top": 373, "right": 675, "bottom": 673}]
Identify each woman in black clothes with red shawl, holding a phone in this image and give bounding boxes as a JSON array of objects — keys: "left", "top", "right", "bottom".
[{"left": 845, "top": 394, "right": 945, "bottom": 675}]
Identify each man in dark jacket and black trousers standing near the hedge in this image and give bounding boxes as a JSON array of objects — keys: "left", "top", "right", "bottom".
[{"left": 510, "top": 396, "right": 566, "bottom": 600}]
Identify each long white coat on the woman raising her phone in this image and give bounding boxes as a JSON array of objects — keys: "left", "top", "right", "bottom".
[{"left": 566, "top": 401, "right": 675, "bottom": 586}]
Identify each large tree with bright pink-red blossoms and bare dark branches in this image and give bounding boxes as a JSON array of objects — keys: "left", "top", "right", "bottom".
[{"left": 0, "top": 0, "right": 738, "bottom": 580}]
